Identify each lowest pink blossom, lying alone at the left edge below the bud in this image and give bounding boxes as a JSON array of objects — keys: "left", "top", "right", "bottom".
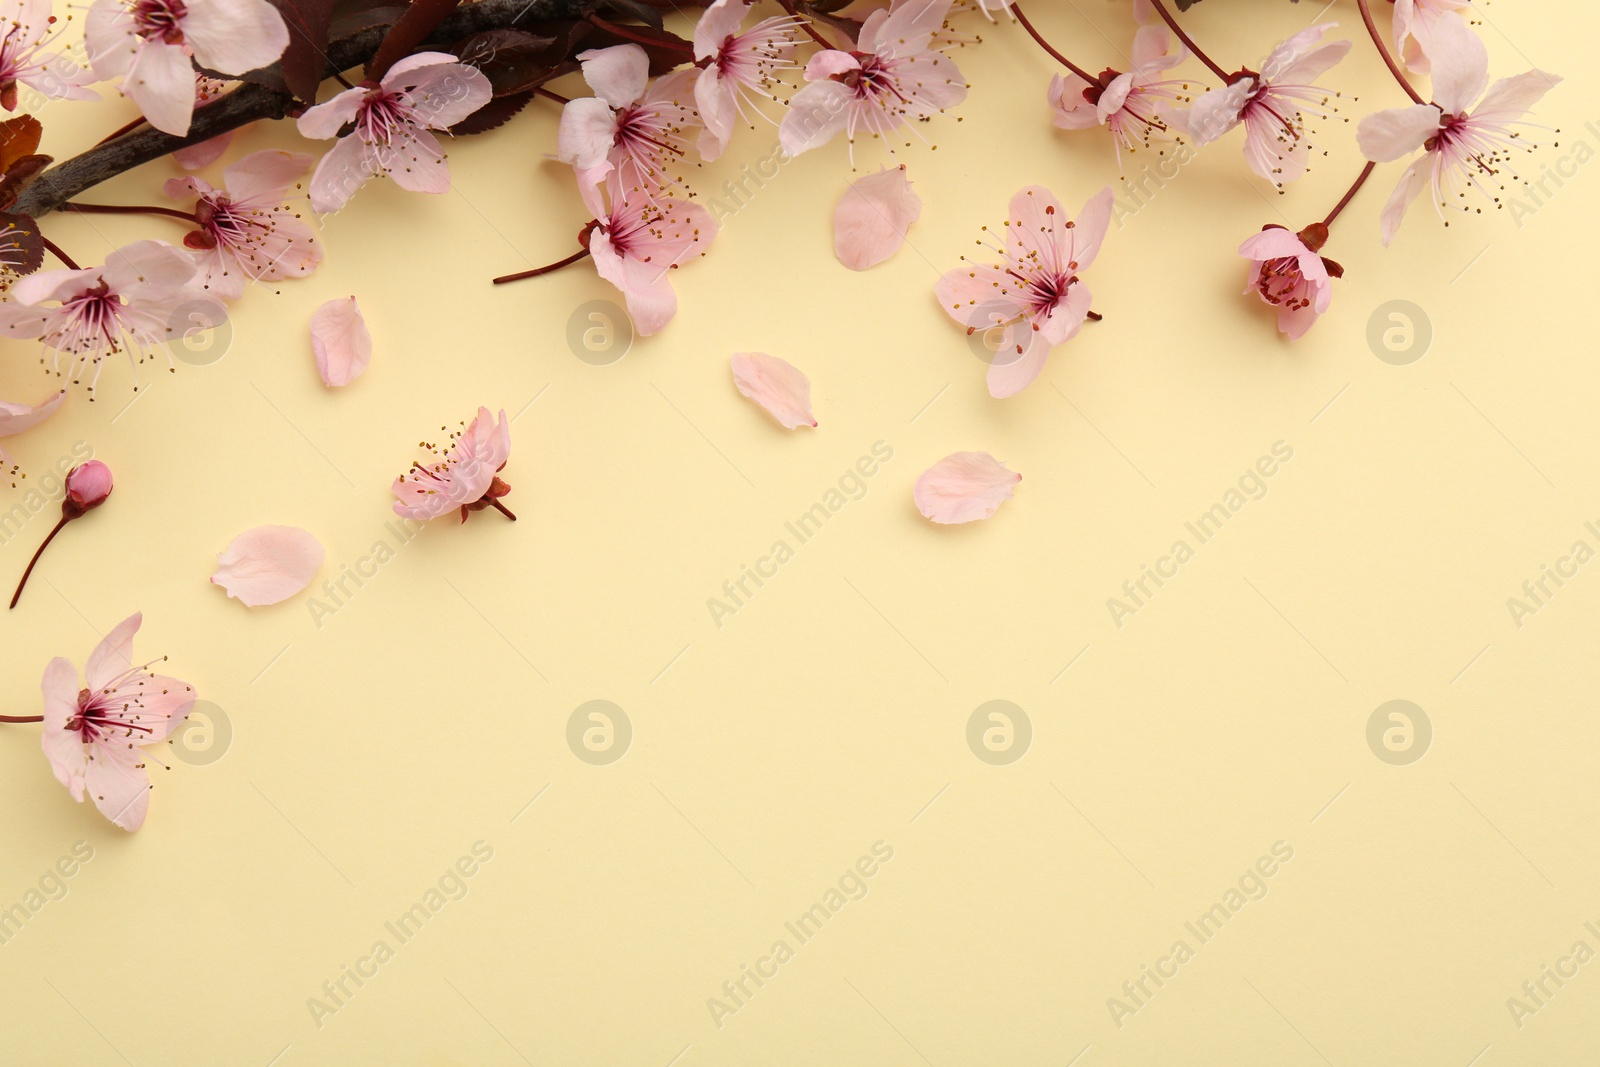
[{"left": 40, "top": 614, "right": 195, "bottom": 830}]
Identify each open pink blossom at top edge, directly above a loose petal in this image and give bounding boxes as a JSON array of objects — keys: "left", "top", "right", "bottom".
[{"left": 778, "top": 0, "right": 966, "bottom": 155}]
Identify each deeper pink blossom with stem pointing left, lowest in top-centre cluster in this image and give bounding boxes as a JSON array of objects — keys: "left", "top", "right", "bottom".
[{"left": 586, "top": 173, "right": 717, "bottom": 338}]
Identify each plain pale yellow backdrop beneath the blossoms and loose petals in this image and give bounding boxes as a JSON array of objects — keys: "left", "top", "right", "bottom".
[{"left": 0, "top": 0, "right": 1600, "bottom": 1067}]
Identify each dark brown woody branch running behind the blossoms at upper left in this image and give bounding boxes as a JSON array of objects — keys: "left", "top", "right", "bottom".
[{"left": 11, "top": 0, "right": 606, "bottom": 219}]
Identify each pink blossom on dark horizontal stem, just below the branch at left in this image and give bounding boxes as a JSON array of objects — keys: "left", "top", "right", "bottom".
[{"left": 166, "top": 149, "right": 322, "bottom": 301}]
